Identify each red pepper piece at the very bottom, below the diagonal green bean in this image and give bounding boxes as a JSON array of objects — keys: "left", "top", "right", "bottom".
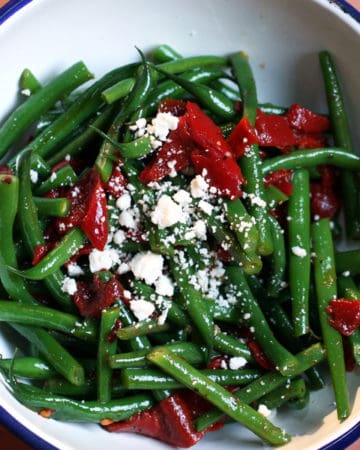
[{"left": 106, "top": 392, "right": 206, "bottom": 448}]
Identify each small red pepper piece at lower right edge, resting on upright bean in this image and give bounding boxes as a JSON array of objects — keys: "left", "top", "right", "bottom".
[{"left": 326, "top": 298, "right": 360, "bottom": 336}]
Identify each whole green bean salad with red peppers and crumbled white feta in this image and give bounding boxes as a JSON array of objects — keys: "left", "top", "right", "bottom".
[{"left": 0, "top": 45, "right": 360, "bottom": 448}]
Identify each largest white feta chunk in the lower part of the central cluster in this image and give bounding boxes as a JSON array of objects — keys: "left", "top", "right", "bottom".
[{"left": 129, "top": 251, "right": 164, "bottom": 284}]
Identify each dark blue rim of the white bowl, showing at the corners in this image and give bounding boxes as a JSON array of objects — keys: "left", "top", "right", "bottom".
[{"left": 0, "top": 0, "right": 360, "bottom": 450}]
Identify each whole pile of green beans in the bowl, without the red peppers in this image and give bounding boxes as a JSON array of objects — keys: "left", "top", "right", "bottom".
[{"left": 0, "top": 45, "right": 360, "bottom": 446}]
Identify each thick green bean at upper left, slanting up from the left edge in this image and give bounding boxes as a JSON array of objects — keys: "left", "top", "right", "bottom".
[{"left": 0, "top": 61, "right": 92, "bottom": 161}]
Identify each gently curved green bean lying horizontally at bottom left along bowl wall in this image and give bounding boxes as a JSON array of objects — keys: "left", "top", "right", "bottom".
[{"left": 7, "top": 382, "right": 153, "bottom": 422}]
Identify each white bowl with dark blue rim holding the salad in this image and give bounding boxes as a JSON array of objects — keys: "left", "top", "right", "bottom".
[{"left": 0, "top": 0, "right": 360, "bottom": 450}]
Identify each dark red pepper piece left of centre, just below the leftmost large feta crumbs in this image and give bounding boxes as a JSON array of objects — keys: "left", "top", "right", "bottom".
[{"left": 73, "top": 273, "right": 124, "bottom": 317}]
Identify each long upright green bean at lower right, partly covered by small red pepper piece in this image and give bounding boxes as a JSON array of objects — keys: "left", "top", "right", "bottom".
[{"left": 312, "top": 219, "right": 350, "bottom": 421}]
